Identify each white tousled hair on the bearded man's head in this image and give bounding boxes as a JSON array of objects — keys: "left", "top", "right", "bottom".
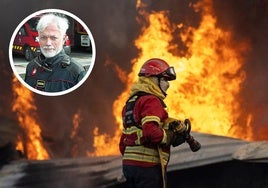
[{"left": 36, "top": 13, "right": 69, "bottom": 35}]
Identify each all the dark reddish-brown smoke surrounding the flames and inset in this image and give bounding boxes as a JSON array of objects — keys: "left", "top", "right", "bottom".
[{"left": 0, "top": 0, "right": 268, "bottom": 157}]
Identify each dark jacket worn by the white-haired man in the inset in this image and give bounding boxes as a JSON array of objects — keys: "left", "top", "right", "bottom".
[{"left": 25, "top": 50, "right": 86, "bottom": 92}]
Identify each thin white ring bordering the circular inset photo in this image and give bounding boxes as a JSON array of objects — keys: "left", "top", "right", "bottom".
[{"left": 9, "top": 9, "right": 96, "bottom": 96}]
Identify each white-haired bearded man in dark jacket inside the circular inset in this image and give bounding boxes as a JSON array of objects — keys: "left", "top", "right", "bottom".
[{"left": 25, "top": 13, "right": 86, "bottom": 92}]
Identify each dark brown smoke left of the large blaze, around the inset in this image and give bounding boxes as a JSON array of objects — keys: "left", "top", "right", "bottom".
[{"left": 0, "top": 0, "right": 139, "bottom": 157}]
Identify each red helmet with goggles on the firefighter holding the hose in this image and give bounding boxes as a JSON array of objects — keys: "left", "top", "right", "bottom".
[{"left": 139, "top": 58, "right": 176, "bottom": 81}]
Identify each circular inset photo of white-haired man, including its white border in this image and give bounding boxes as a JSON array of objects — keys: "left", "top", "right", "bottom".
[{"left": 9, "top": 9, "right": 96, "bottom": 96}]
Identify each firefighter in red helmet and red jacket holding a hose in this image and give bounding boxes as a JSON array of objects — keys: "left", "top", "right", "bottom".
[{"left": 119, "top": 58, "right": 201, "bottom": 188}]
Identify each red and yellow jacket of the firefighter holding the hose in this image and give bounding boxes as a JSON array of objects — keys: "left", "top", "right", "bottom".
[{"left": 119, "top": 77, "right": 170, "bottom": 167}]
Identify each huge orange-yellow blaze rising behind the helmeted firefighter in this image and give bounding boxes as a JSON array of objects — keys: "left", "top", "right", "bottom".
[{"left": 90, "top": 0, "right": 252, "bottom": 155}]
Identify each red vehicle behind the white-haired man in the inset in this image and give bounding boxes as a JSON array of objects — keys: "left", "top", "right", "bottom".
[{"left": 12, "top": 16, "right": 71, "bottom": 61}]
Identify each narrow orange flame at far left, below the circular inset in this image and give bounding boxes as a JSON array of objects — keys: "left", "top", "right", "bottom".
[{"left": 12, "top": 77, "right": 49, "bottom": 160}]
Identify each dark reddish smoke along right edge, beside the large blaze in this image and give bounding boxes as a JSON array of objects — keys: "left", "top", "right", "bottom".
[{"left": 211, "top": 0, "right": 268, "bottom": 140}]
